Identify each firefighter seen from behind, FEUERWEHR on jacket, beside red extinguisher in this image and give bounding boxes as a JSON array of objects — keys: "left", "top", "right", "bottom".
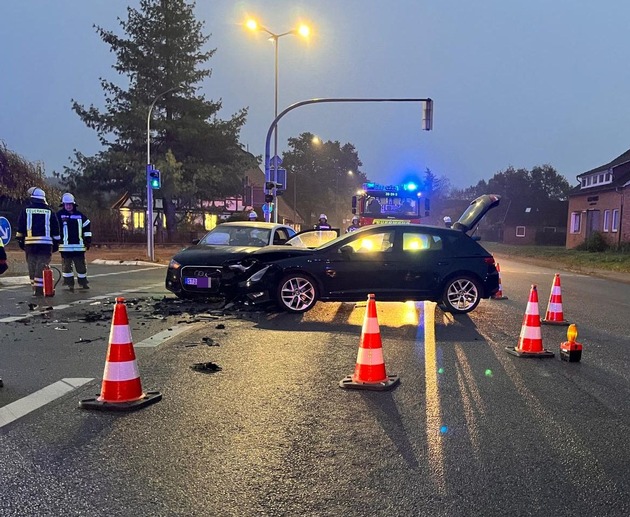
[{"left": 15, "top": 188, "right": 61, "bottom": 296}]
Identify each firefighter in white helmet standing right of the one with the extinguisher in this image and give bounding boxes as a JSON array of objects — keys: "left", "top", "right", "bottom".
[{"left": 57, "top": 192, "right": 92, "bottom": 291}]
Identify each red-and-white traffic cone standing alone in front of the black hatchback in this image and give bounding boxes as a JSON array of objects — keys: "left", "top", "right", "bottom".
[{"left": 339, "top": 294, "right": 400, "bottom": 391}]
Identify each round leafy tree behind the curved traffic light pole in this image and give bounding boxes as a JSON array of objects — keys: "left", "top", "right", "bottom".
[{"left": 282, "top": 132, "right": 368, "bottom": 227}]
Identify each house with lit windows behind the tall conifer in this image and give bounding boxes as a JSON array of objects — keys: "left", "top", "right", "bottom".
[{"left": 112, "top": 168, "right": 304, "bottom": 242}]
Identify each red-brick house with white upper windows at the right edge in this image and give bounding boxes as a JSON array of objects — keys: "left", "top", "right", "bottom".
[{"left": 566, "top": 149, "right": 630, "bottom": 248}]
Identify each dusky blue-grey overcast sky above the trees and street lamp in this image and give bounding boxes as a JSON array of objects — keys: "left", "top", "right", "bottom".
[{"left": 0, "top": 0, "right": 630, "bottom": 187}]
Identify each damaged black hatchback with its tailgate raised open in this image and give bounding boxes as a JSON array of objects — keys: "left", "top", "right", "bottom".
[{"left": 169, "top": 195, "right": 500, "bottom": 313}]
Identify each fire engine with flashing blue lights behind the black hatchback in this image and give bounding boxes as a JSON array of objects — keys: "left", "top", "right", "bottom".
[{"left": 352, "top": 182, "right": 430, "bottom": 226}]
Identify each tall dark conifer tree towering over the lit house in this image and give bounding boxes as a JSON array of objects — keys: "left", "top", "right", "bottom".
[{"left": 61, "top": 0, "right": 257, "bottom": 239}]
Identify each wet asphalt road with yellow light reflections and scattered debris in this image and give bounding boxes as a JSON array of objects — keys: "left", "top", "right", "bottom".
[{"left": 0, "top": 261, "right": 630, "bottom": 516}]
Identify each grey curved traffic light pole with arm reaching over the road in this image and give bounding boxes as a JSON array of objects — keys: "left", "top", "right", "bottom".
[{"left": 263, "top": 97, "right": 433, "bottom": 223}]
